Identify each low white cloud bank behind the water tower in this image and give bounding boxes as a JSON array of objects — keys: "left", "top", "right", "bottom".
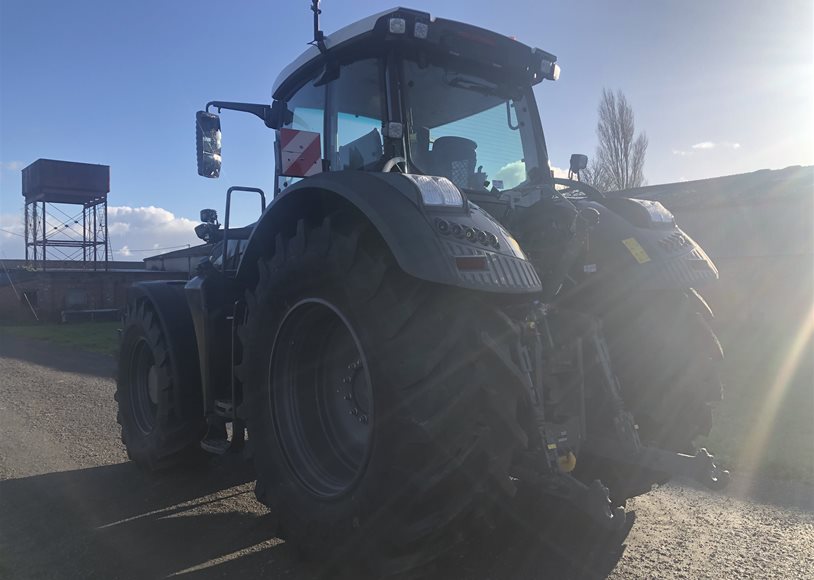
[{"left": 0, "top": 206, "right": 201, "bottom": 260}]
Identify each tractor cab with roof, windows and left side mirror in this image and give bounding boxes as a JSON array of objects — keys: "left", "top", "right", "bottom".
[{"left": 198, "top": 8, "right": 559, "bottom": 196}]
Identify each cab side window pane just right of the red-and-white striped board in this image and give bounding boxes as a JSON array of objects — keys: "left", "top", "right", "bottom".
[{"left": 329, "top": 58, "right": 384, "bottom": 171}]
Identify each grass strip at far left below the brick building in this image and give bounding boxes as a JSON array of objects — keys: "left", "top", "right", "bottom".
[{"left": 0, "top": 322, "right": 121, "bottom": 354}]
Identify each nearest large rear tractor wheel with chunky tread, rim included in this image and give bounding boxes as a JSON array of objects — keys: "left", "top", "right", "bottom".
[{"left": 239, "top": 213, "right": 528, "bottom": 576}]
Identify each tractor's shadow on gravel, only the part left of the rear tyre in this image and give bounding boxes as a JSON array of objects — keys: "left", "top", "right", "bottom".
[{"left": 0, "top": 458, "right": 306, "bottom": 579}]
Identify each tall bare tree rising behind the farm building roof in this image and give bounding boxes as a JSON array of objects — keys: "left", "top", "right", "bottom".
[{"left": 583, "top": 89, "right": 647, "bottom": 191}]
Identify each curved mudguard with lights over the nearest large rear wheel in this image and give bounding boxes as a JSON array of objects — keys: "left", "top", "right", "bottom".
[{"left": 237, "top": 171, "right": 541, "bottom": 294}]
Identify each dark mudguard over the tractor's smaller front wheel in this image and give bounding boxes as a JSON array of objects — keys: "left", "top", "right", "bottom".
[{"left": 127, "top": 280, "right": 203, "bottom": 422}]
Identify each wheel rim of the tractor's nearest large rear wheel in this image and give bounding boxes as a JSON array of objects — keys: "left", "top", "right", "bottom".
[{"left": 268, "top": 299, "right": 374, "bottom": 496}]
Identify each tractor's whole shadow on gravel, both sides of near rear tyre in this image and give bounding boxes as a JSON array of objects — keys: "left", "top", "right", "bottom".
[{"left": 0, "top": 457, "right": 624, "bottom": 580}]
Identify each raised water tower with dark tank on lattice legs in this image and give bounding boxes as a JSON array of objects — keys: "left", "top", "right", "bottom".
[{"left": 23, "top": 159, "right": 110, "bottom": 270}]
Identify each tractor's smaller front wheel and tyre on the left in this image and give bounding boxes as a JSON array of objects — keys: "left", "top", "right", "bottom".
[{"left": 114, "top": 297, "right": 205, "bottom": 471}]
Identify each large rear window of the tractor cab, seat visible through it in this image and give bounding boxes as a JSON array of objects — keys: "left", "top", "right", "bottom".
[{"left": 404, "top": 60, "right": 540, "bottom": 190}]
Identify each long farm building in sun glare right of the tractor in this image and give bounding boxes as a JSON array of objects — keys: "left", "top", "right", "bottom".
[{"left": 612, "top": 166, "right": 814, "bottom": 326}]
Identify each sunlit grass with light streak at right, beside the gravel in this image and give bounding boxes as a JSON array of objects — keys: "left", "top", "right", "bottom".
[{"left": 701, "top": 322, "right": 814, "bottom": 484}]
